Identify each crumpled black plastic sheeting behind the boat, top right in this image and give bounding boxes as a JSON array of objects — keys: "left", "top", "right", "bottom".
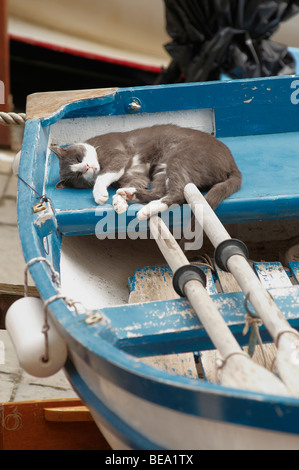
[{"left": 158, "top": 0, "right": 299, "bottom": 83}]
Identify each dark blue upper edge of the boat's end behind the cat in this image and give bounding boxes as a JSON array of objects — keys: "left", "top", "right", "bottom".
[{"left": 41, "top": 76, "right": 298, "bottom": 138}]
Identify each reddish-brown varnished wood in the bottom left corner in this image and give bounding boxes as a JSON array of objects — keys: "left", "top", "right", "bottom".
[{"left": 0, "top": 398, "right": 111, "bottom": 450}]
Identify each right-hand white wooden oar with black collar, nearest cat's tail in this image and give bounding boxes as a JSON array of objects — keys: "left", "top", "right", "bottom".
[{"left": 185, "top": 183, "right": 299, "bottom": 396}]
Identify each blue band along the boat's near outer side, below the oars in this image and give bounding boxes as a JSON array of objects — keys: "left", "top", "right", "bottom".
[{"left": 58, "top": 308, "right": 299, "bottom": 434}]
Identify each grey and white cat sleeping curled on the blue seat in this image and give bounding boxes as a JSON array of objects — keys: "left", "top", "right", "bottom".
[{"left": 51, "top": 124, "right": 241, "bottom": 220}]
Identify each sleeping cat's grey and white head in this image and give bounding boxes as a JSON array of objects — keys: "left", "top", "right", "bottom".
[{"left": 50, "top": 144, "right": 100, "bottom": 189}]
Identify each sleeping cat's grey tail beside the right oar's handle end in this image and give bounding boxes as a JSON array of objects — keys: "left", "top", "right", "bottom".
[{"left": 179, "top": 168, "right": 242, "bottom": 251}]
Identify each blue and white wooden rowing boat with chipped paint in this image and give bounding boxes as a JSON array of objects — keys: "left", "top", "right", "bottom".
[{"left": 8, "top": 62, "right": 299, "bottom": 450}]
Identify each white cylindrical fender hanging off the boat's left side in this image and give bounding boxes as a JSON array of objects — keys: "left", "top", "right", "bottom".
[{"left": 5, "top": 297, "right": 67, "bottom": 377}]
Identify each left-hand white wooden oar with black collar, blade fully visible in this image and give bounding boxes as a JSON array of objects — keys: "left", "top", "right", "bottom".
[{"left": 149, "top": 216, "right": 289, "bottom": 395}]
